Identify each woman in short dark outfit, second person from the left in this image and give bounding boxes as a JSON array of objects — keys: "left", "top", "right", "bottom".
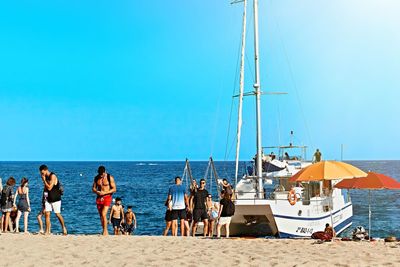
[{"left": 14, "top": 177, "right": 31, "bottom": 233}]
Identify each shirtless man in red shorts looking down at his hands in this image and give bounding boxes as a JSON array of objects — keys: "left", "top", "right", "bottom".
[{"left": 92, "top": 166, "right": 117, "bottom": 235}]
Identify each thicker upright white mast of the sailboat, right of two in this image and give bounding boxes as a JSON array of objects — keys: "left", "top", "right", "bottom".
[{"left": 253, "top": 0, "right": 263, "bottom": 198}]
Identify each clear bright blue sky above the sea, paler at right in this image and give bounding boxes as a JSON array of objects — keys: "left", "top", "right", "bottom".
[{"left": 0, "top": 0, "right": 400, "bottom": 160}]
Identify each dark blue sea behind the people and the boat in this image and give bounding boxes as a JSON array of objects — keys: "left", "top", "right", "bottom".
[{"left": 0, "top": 161, "right": 400, "bottom": 237}]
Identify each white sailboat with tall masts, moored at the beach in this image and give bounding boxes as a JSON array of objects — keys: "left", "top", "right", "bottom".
[{"left": 230, "top": 0, "right": 353, "bottom": 237}]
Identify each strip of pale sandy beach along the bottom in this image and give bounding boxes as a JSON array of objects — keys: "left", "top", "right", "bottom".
[{"left": 0, "top": 234, "right": 400, "bottom": 266}]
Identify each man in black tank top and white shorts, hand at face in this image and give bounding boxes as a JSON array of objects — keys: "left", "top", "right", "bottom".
[{"left": 39, "top": 165, "right": 67, "bottom": 235}]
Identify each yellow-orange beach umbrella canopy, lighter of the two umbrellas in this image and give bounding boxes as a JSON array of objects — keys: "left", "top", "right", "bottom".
[{"left": 289, "top": 161, "right": 367, "bottom": 182}]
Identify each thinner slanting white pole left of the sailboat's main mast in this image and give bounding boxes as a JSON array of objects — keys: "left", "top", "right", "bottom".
[{"left": 235, "top": 0, "right": 247, "bottom": 184}]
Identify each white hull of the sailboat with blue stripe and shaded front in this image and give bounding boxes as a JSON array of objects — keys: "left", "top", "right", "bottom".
[{"left": 230, "top": 201, "right": 353, "bottom": 238}]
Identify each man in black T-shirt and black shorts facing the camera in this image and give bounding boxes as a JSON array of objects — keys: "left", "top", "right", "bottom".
[{"left": 191, "top": 179, "right": 208, "bottom": 237}]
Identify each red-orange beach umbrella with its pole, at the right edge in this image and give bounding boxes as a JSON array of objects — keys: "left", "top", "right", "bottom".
[{"left": 335, "top": 172, "right": 400, "bottom": 240}]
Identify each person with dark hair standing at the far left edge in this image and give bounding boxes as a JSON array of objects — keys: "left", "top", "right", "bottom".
[{"left": 0, "top": 177, "right": 15, "bottom": 232}]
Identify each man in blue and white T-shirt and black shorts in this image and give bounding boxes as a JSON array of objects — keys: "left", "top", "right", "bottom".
[{"left": 168, "top": 176, "right": 189, "bottom": 236}]
